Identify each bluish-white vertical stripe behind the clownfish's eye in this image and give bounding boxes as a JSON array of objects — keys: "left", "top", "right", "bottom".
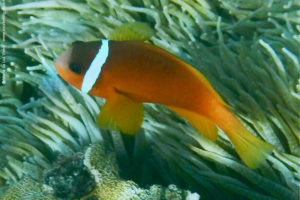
[{"left": 81, "top": 39, "right": 109, "bottom": 93}]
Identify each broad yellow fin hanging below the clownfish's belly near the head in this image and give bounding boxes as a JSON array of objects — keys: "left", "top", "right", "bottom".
[{"left": 97, "top": 93, "right": 144, "bottom": 135}]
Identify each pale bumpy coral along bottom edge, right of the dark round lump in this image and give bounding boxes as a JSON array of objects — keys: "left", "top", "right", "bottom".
[{"left": 84, "top": 144, "right": 200, "bottom": 200}]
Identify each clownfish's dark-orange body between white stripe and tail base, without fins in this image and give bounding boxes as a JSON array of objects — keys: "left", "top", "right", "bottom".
[{"left": 90, "top": 41, "right": 222, "bottom": 111}]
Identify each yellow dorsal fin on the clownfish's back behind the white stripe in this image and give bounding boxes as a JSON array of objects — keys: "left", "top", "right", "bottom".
[{"left": 108, "top": 22, "right": 154, "bottom": 41}]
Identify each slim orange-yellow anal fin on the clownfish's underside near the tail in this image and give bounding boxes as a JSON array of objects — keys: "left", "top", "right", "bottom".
[{"left": 168, "top": 106, "right": 218, "bottom": 141}]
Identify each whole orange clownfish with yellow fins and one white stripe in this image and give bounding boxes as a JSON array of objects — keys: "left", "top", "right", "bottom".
[{"left": 55, "top": 23, "right": 273, "bottom": 168}]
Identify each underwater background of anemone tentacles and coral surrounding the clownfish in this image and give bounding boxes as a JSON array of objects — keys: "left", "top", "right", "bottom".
[{"left": 0, "top": 0, "right": 300, "bottom": 200}]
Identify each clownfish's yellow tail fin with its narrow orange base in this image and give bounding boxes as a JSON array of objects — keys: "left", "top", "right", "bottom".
[{"left": 214, "top": 106, "right": 273, "bottom": 169}]
